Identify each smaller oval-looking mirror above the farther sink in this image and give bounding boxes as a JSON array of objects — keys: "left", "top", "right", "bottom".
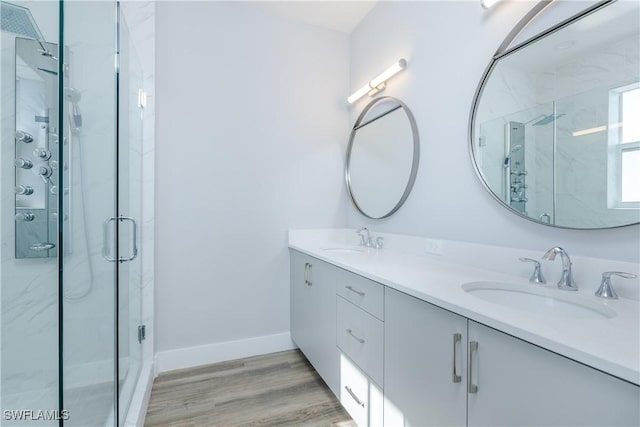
[{"left": 345, "top": 96, "right": 420, "bottom": 219}]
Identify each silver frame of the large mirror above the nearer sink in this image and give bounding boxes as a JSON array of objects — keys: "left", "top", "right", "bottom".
[{"left": 468, "top": 0, "right": 640, "bottom": 230}]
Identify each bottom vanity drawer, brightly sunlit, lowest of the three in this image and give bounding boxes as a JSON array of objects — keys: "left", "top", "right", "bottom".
[{"left": 338, "top": 354, "right": 384, "bottom": 427}]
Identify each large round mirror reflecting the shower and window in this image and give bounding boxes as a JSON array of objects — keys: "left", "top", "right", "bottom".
[{"left": 470, "top": 1, "right": 640, "bottom": 229}]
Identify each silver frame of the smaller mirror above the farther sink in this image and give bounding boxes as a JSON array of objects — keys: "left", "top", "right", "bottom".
[{"left": 344, "top": 96, "right": 420, "bottom": 219}]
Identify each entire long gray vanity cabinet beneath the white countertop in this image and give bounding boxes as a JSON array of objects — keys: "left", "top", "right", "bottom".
[{"left": 291, "top": 250, "right": 640, "bottom": 427}]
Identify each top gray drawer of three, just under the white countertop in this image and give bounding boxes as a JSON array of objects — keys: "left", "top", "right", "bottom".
[{"left": 335, "top": 270, "right": 384, "bottom": 320}]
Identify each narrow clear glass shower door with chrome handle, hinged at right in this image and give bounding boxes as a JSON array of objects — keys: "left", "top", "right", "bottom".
[{"left": 118, "top": 10, "right": 145, "bottom": 425}]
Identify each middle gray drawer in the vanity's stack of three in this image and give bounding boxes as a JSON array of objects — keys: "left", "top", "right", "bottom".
[{"left": 336, "top": 296, "right": 384, "bottom": 386}]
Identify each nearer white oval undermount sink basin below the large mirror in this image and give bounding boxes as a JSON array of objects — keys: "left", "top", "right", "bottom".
[{"left": 462, "top": 282, "right": 616, "bottom": 319}]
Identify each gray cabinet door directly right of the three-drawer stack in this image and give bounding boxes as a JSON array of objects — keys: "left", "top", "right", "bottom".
[{"left": 384, "top": 288, "right": 467, "bottom": 427}]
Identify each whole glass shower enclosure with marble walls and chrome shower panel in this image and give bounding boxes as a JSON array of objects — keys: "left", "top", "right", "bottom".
[{"left": 0, "top": 1, "right": 145, "bottom": 427}]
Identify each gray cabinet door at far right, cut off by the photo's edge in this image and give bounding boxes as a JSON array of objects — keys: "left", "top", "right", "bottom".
[{"left": 468, "top": 321, "right": 640, "bottom": 427}]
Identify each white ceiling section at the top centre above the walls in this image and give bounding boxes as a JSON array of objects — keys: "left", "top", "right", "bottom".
[{"left": 254, "top": 0, "right": 377, "bottom": 34}]
